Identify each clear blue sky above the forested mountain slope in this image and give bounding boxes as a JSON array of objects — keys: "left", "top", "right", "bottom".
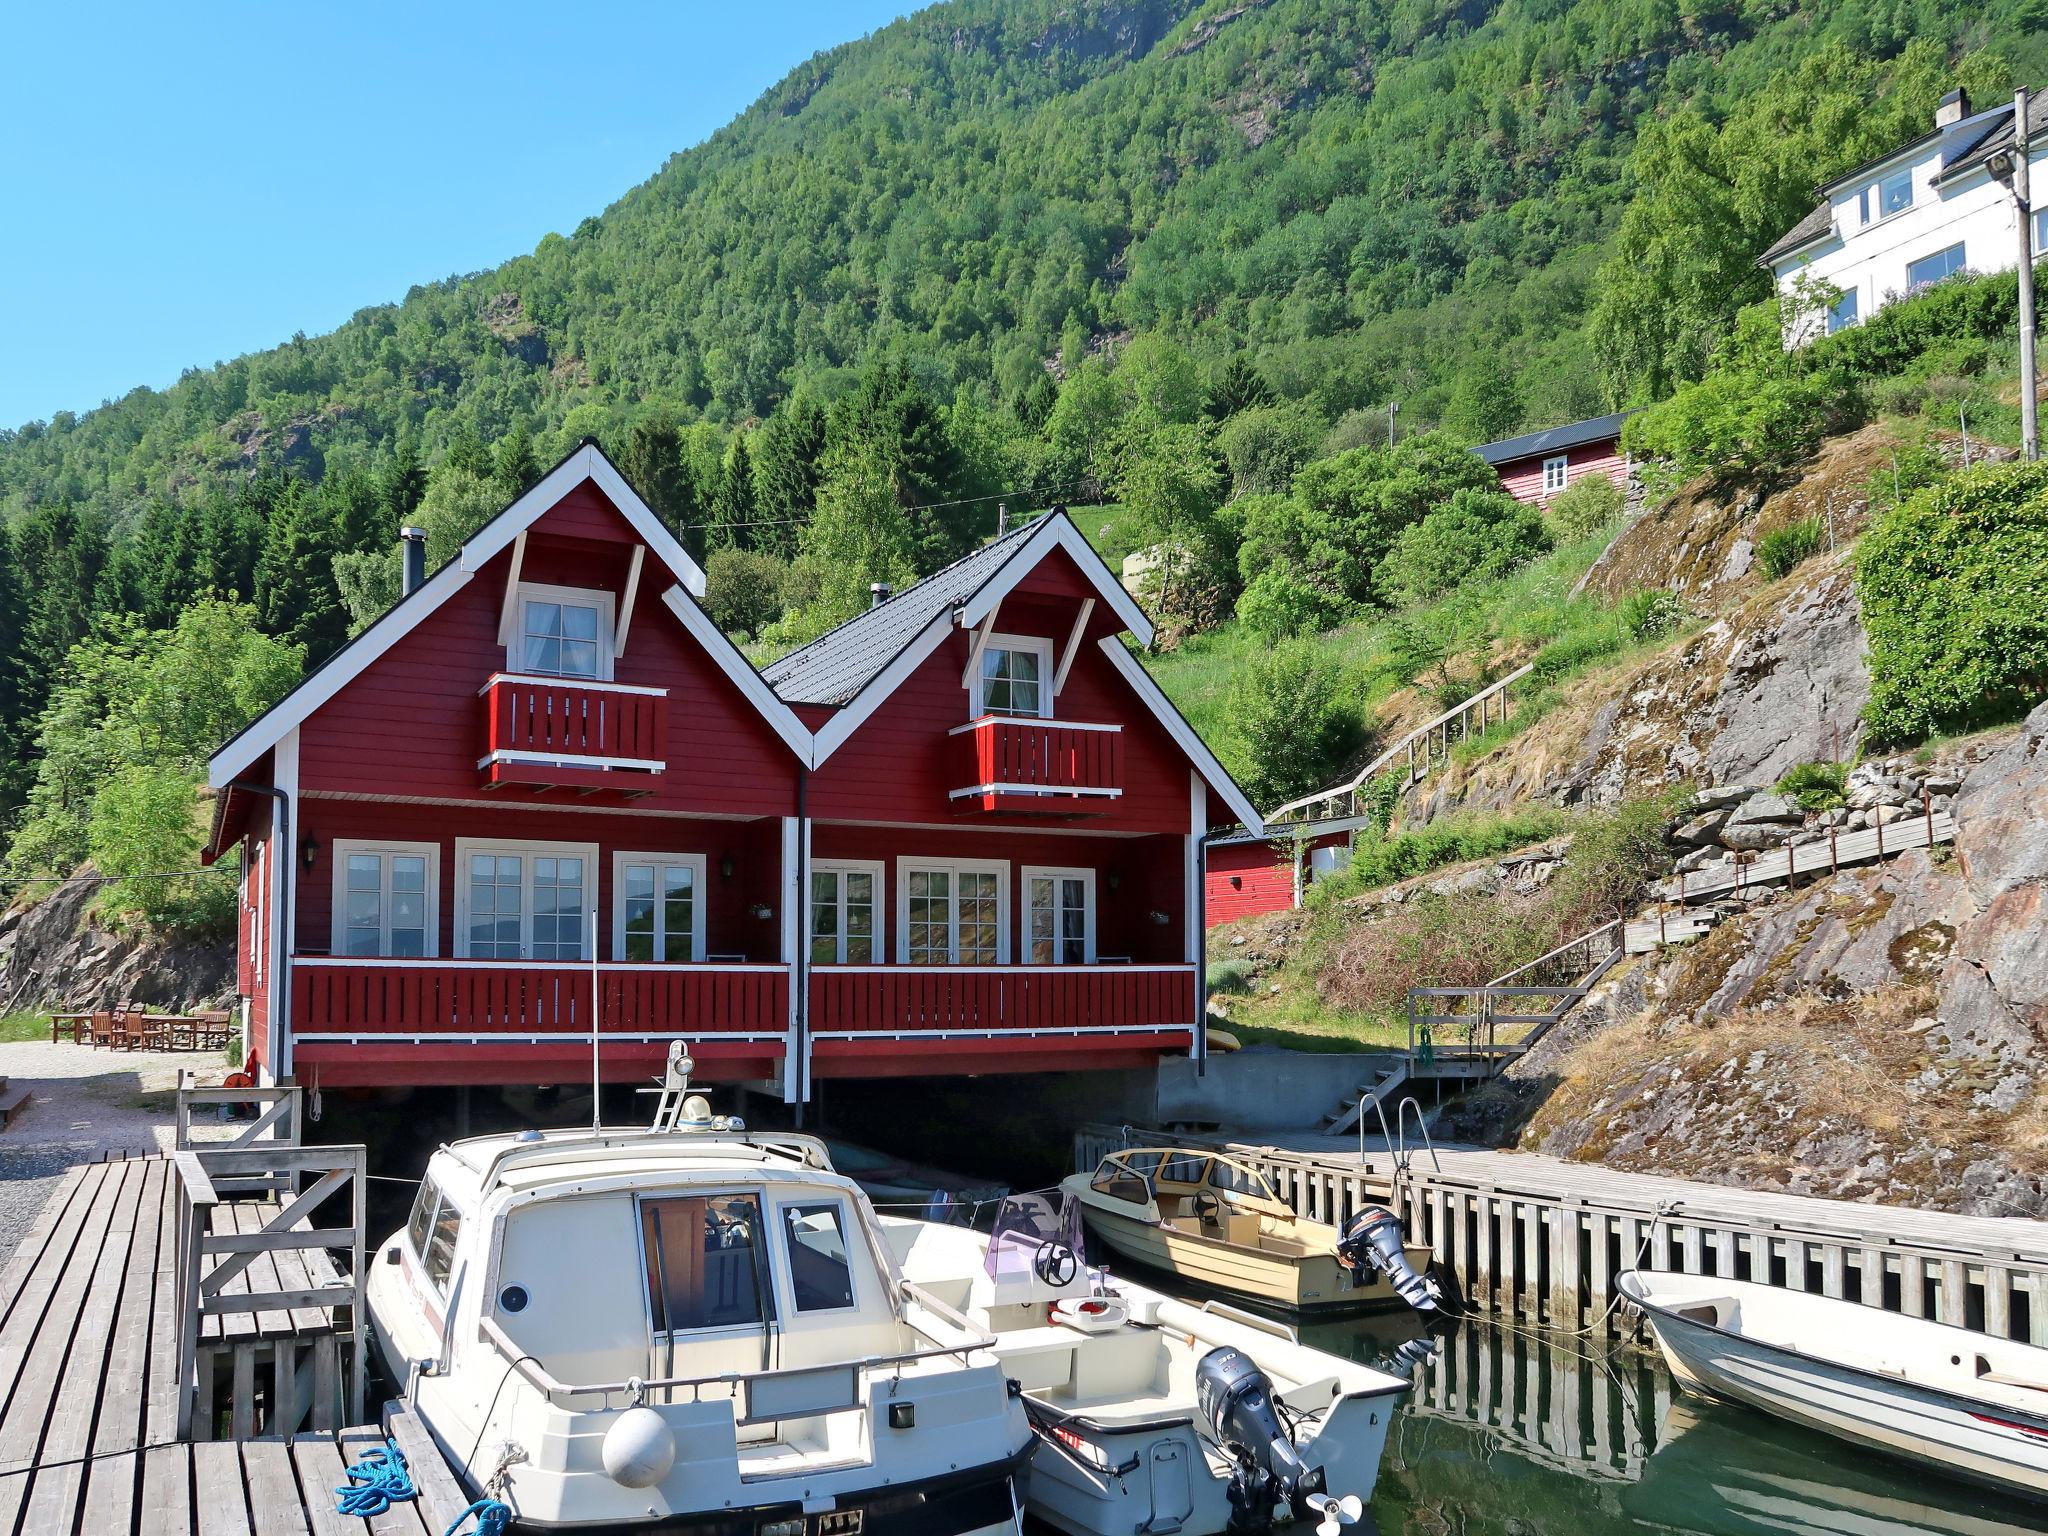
[{"left": 0, "top": 0, "right": 913, "bottom": 426}]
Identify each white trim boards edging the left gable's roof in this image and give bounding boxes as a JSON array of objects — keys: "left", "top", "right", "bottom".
[{"left": 207, "top": 438, "right": 811, "bottom": 788}]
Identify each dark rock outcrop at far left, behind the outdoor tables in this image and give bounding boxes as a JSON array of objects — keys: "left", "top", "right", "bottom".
[{"left": 0, "top": 881, "right": 236, "bottom": 1014}]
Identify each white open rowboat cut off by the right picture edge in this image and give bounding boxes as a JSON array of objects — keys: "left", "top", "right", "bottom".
[{"left": 1618, "top": 1270, "right": 2048, "bottom": 1499}]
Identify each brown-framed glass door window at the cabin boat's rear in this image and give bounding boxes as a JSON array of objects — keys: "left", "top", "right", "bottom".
[{"left": 641, "top": 1194, "right": 774, "bottom": 1333}]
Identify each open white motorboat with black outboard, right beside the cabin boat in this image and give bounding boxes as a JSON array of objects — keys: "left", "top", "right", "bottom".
[{"left": 883, "top": 1190, "right": 1409, "bottom": 1536}]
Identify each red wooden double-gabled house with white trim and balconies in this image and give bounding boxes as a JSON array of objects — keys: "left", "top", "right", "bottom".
[{"left": 207, "top": 444, "right": 1257, "bottom": 1100}]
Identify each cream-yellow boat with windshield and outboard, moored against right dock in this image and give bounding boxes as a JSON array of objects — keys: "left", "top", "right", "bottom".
[{"left": 1061, "top": 1147, "right": 1436, "bottom": 1313}]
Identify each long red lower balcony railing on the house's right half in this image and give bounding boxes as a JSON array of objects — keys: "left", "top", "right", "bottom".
[{"left": 809, "top": 965, "right": 1196, "bottom": 1034}]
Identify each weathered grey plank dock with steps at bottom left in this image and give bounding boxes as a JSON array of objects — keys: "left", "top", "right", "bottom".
[{"left": 0, "top": 1149, "right": 467, "bottom": 1536}]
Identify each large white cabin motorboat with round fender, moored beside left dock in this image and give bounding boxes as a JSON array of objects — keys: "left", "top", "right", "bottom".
[{"left": 367, "top": 1059, "right": 1032, "bottom": 1536}]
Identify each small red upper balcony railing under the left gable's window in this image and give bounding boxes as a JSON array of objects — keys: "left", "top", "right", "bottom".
[{"left": 477, "top": 672, "right": 668, "bottom": 795}]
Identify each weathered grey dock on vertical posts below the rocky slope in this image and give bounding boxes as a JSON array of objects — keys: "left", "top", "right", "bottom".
[{"left": 1075, "top": 1126, "right": 2048, "bottom": 1346}]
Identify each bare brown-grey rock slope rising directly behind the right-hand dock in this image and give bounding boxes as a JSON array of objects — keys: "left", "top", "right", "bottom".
[{"left": 1444, "top": 705, "right": 2048, "bottom": 1214}]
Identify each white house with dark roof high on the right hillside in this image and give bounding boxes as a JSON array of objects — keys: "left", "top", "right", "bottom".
[{"left": 1757, "top": 90, "right": 2048, "bottom": 346}]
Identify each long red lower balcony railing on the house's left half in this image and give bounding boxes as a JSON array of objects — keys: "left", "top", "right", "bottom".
[{"left": 291, "top": 958, "right": 788, "bottom": 1042}]
